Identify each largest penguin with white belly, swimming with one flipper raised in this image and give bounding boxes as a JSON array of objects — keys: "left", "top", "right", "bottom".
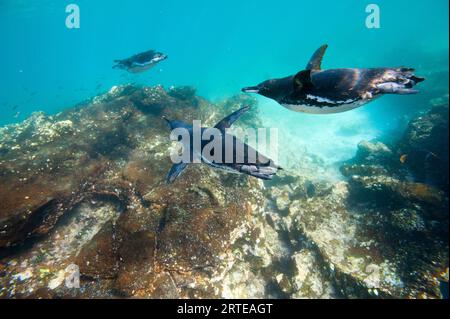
[{"left": 242, "top": 45, "right": 425, "bottom": 114}]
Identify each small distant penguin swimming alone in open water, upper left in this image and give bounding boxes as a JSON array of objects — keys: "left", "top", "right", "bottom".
[{"left": 113, "top": 50, "right": 167, "bottom": 73}]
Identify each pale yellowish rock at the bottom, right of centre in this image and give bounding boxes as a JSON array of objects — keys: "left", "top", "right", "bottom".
[{"left": 286, "top": 183, "right": 397, "bottom": 298}]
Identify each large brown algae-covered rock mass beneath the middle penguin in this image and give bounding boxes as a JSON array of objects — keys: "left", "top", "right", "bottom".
[{"left": 0, "top": 86, "right": 268, "bottom": 298}]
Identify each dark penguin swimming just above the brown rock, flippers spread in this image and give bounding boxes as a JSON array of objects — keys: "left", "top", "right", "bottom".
[{"left": 164, "top": 106, "right": 281, "bottom": 183}]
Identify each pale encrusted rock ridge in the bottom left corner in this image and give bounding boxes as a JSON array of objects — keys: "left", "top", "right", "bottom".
[{"left": 0, "top": 198, "right": 121, "bottom": 298}]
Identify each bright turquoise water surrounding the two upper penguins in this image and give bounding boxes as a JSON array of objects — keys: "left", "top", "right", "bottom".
[{"left": 0, "top": 0, "right": 449, "bottom": 168}]
